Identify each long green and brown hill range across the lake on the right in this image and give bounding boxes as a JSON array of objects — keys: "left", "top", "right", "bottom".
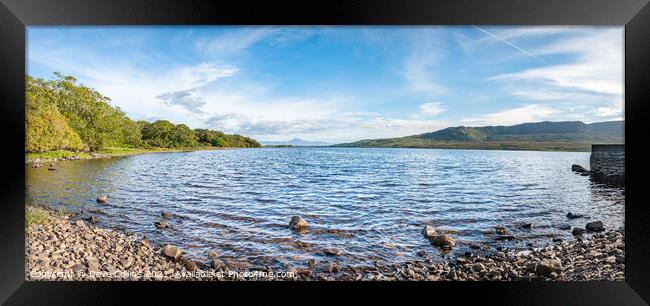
[{"left": 336, "top": 121, "right": 625, "bottom": 151}]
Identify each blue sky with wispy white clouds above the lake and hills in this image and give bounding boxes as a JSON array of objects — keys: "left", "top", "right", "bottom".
[{"left": 27, "top": 26, "right": 624, "bottom": 143}]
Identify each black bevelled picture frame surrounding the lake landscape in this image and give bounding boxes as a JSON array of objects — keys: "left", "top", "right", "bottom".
[{"left": 0, "top": 0, "right": 650, "bottom": 305}]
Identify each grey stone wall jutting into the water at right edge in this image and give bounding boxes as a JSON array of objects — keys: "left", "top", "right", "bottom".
[{"left": 589, "top": 144, "right": 625, "bottom": 179}]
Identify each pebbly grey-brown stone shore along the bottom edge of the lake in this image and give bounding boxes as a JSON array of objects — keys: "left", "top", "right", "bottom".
[{"left": 25, "top": 206, "right": 625, "bottom": 281}]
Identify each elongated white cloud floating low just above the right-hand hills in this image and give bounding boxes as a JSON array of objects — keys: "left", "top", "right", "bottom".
[{"left": 461, "top": 104, "right": 559, "bottom": 125}]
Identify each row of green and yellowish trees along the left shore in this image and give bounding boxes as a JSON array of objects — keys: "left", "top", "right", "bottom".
[{"left": 25, "top": 73, "right": 260, "bottom": 152}]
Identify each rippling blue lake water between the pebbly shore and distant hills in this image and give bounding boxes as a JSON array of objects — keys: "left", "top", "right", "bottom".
[{"left": 25, "top": 148, "right": 625, "bottom": 266}]
